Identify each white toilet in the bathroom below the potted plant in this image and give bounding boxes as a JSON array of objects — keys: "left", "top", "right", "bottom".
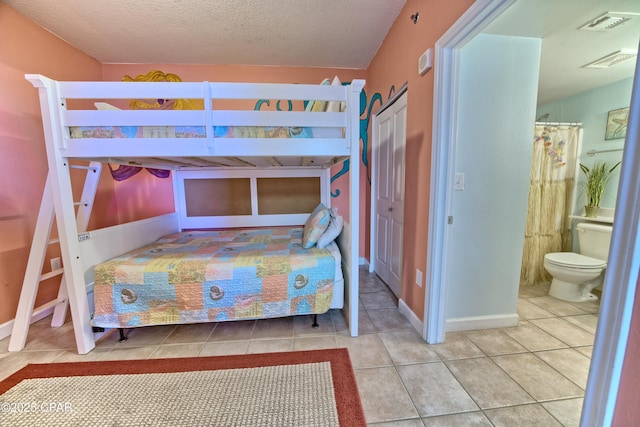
[{"left": 544, "top": 222, "right": 613, "bottom": 302}]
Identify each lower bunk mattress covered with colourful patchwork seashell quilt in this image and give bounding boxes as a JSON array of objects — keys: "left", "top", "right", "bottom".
[{"left": 92, "top": 227, "right": 344, "bottom": 328}]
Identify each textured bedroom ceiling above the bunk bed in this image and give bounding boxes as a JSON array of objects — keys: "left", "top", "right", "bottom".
[{"left": 2, "top": 0, "right": 406, "bottom": 69}]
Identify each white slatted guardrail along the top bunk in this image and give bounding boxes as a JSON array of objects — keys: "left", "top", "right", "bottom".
[{"left": 26, "top": 75, "right": 364, "bottom": 163}]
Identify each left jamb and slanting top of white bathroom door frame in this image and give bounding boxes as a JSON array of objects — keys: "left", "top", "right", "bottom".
[{"left": 422, "top": 0, "right": 516, "bottom": 344}]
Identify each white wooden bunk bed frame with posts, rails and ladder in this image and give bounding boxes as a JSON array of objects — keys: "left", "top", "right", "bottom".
[{"left": 9, "top": 74, "right": 365, "bottom": 354}]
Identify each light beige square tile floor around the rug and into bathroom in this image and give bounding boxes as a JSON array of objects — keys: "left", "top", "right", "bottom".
[{"left": 0, "top": 269, "right": 599, "bottom": 427}]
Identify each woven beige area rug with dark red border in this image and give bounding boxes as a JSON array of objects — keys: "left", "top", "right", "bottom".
[{"left": 0, "top": 349, "right": 366, "bottom": 427}]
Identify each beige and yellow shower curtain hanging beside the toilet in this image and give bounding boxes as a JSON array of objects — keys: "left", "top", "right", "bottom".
[{"left": 520, "top": 124, "right": 582, "bottom": 285}]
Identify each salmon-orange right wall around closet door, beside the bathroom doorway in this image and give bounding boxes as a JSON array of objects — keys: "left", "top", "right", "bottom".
[{"left": 361, "top": 0, "right": 473, "bottom": 318}]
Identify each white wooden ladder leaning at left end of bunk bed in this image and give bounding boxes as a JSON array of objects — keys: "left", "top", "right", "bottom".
[{"left": 9, "top": 162, "right": 102, "bottom": 351}]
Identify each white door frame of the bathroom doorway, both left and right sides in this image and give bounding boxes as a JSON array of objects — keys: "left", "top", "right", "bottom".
[{"left": 422, "top": 0, "right": 640, "bottom": 426}]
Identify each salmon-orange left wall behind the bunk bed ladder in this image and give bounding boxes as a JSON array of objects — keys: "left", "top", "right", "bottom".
[{"left": 0, "top": 3, "right": 102, "bottom": 326}]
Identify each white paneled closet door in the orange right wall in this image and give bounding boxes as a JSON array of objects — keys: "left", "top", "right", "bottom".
[{"left": 373, "top": 92, "right": 407, "bottom": 297}]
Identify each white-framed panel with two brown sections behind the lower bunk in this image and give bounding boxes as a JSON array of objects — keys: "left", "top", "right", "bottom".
[{"left": 174, "top": 168, "right": 331, "bottom": 229}]
